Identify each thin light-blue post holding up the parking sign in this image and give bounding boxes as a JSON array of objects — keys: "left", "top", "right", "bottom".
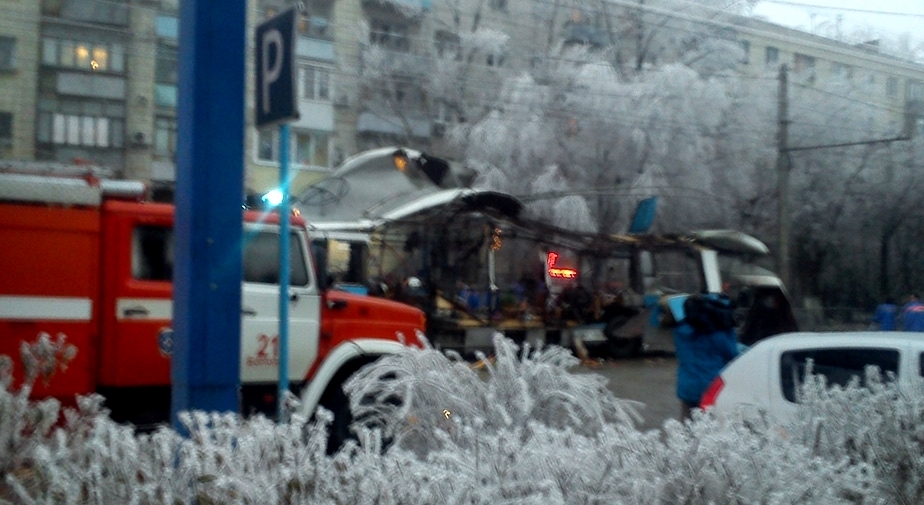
[{"left": 276, "top": 123, "right": 290, "bottom": 423}]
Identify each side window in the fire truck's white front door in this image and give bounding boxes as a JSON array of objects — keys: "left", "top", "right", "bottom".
[{"left": 244, "top": 232, "right": 309, "bottom": 286}]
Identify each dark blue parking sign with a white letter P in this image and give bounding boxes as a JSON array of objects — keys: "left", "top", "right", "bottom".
[{"left": 255, "top": 9, "right": 298, "bottom": 127}]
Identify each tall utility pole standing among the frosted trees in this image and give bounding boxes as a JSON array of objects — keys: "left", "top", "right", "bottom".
[{"left": 776, "top": 63, "right": 792, "bottom": 289}]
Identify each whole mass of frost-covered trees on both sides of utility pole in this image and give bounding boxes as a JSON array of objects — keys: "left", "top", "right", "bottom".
[{"left": 350, "top": 0, "right": 924, "bottom": 306}]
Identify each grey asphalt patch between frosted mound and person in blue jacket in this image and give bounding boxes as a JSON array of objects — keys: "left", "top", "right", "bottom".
[{"left": 572, "top": 355, "right": 680, "bottom": 431}]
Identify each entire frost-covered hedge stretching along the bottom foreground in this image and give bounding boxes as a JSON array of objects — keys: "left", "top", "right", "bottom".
[{"left": 0, "top": 332, "right": 924, "bottom": 505}]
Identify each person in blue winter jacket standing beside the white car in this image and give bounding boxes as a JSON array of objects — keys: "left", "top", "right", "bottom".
[{"left": 674, "top": 294, "right": 739, "bottom": 420}]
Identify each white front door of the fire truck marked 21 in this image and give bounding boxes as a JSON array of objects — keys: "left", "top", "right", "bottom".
[{"left": 241, "top": 226, "right": 321, "bottom": 384}]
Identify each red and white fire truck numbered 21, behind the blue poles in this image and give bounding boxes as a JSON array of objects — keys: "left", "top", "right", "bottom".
[{"left": 0, "top": 166, "right": 425, "bottom": 440}]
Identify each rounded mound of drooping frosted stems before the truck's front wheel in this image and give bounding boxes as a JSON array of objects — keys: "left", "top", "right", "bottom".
[{"left": 344, "top": 336, "right": 640, "bottom": 454}]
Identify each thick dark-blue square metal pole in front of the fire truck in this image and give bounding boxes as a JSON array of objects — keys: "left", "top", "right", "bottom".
[{"left": 171, "top": 0, "right": 247, "bottom": 432}]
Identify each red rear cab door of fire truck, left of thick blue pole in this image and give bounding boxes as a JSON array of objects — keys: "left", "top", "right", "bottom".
[{"left": 99, "top": 202, "right": 173, "bottom": 387}]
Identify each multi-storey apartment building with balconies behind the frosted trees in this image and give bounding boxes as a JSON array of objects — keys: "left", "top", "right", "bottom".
[{"left": 0, "top": 0, "right": 924, "bottom": 192}]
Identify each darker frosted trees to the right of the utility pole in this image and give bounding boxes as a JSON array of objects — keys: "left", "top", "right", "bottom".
[{"left": 789, "top": 75, "right": 924, "bottom": 306}]
